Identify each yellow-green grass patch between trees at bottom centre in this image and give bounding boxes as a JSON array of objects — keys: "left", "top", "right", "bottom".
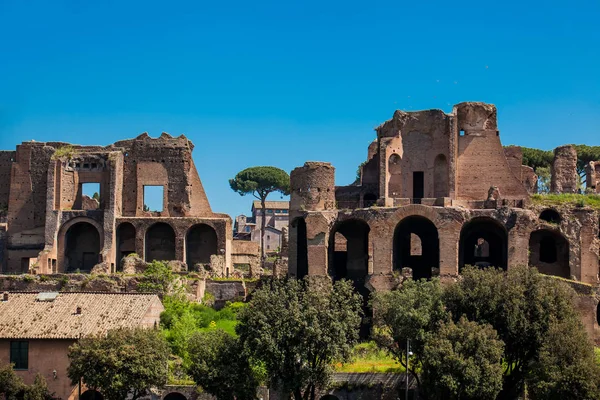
[{"left": 335, "top": 342, "right": 405, "bottom": 373}]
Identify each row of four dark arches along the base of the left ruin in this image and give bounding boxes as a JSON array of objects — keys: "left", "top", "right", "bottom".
[{"left": 59, "top": 221, "right": 218, "bottom": 272}]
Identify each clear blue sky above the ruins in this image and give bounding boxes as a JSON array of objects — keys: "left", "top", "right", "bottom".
[{"left": 0, "top": 0, "right": 600, "bottom": 216}]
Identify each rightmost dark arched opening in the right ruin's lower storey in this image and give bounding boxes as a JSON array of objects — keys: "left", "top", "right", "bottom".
[{"left": 529, "top": 229, "right": 571, "bottom": 278}]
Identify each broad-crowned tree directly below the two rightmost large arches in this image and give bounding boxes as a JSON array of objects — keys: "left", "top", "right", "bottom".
[{"left": 444, "top": 267, "right": 585, "bottom": 399}]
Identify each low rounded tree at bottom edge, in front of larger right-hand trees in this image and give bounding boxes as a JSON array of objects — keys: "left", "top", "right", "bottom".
[{"left": 422, "top": 317, "right": 504, "bottom": 400}]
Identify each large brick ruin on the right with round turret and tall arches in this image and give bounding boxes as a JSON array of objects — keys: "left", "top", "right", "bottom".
[{"left": 288, "top": 103, "right": 600, "bottom": 340}]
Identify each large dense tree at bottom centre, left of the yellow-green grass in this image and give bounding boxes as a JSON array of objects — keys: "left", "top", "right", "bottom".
[{"left": 236, "top": 279, "right": 362, "bottom": 400}]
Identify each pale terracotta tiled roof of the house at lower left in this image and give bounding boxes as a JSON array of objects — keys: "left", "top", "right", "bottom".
[{"left": 0, "top": 292, "right": 164, "bottom": 339}]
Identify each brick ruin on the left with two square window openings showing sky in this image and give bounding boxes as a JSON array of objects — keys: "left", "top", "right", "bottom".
[{"left": 0, "top": 133, "right": 232, "bottom": 274}]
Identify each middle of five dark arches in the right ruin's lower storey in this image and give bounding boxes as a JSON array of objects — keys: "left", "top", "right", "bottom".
[{"left": 394, "top": 215, "right": 440, "bottom": 280}]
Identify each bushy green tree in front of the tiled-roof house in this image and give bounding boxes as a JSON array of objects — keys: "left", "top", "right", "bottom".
[{"left": 67, "top": 328, "right": 169, "bottom": 400}]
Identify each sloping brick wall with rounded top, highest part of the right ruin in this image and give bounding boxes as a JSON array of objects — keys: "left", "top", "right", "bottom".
[{"left": 454, "top": 103, "right": 528, "bottom": 200}]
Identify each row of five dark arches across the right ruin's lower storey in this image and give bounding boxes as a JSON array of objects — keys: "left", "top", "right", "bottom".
[{"left": 292, "top": 215, "right": 570, "bottom": 281}]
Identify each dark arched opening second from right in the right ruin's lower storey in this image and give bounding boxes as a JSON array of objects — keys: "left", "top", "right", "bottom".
[{"left": 459, "top": 217, "right": 508, "bottom": 270}]
